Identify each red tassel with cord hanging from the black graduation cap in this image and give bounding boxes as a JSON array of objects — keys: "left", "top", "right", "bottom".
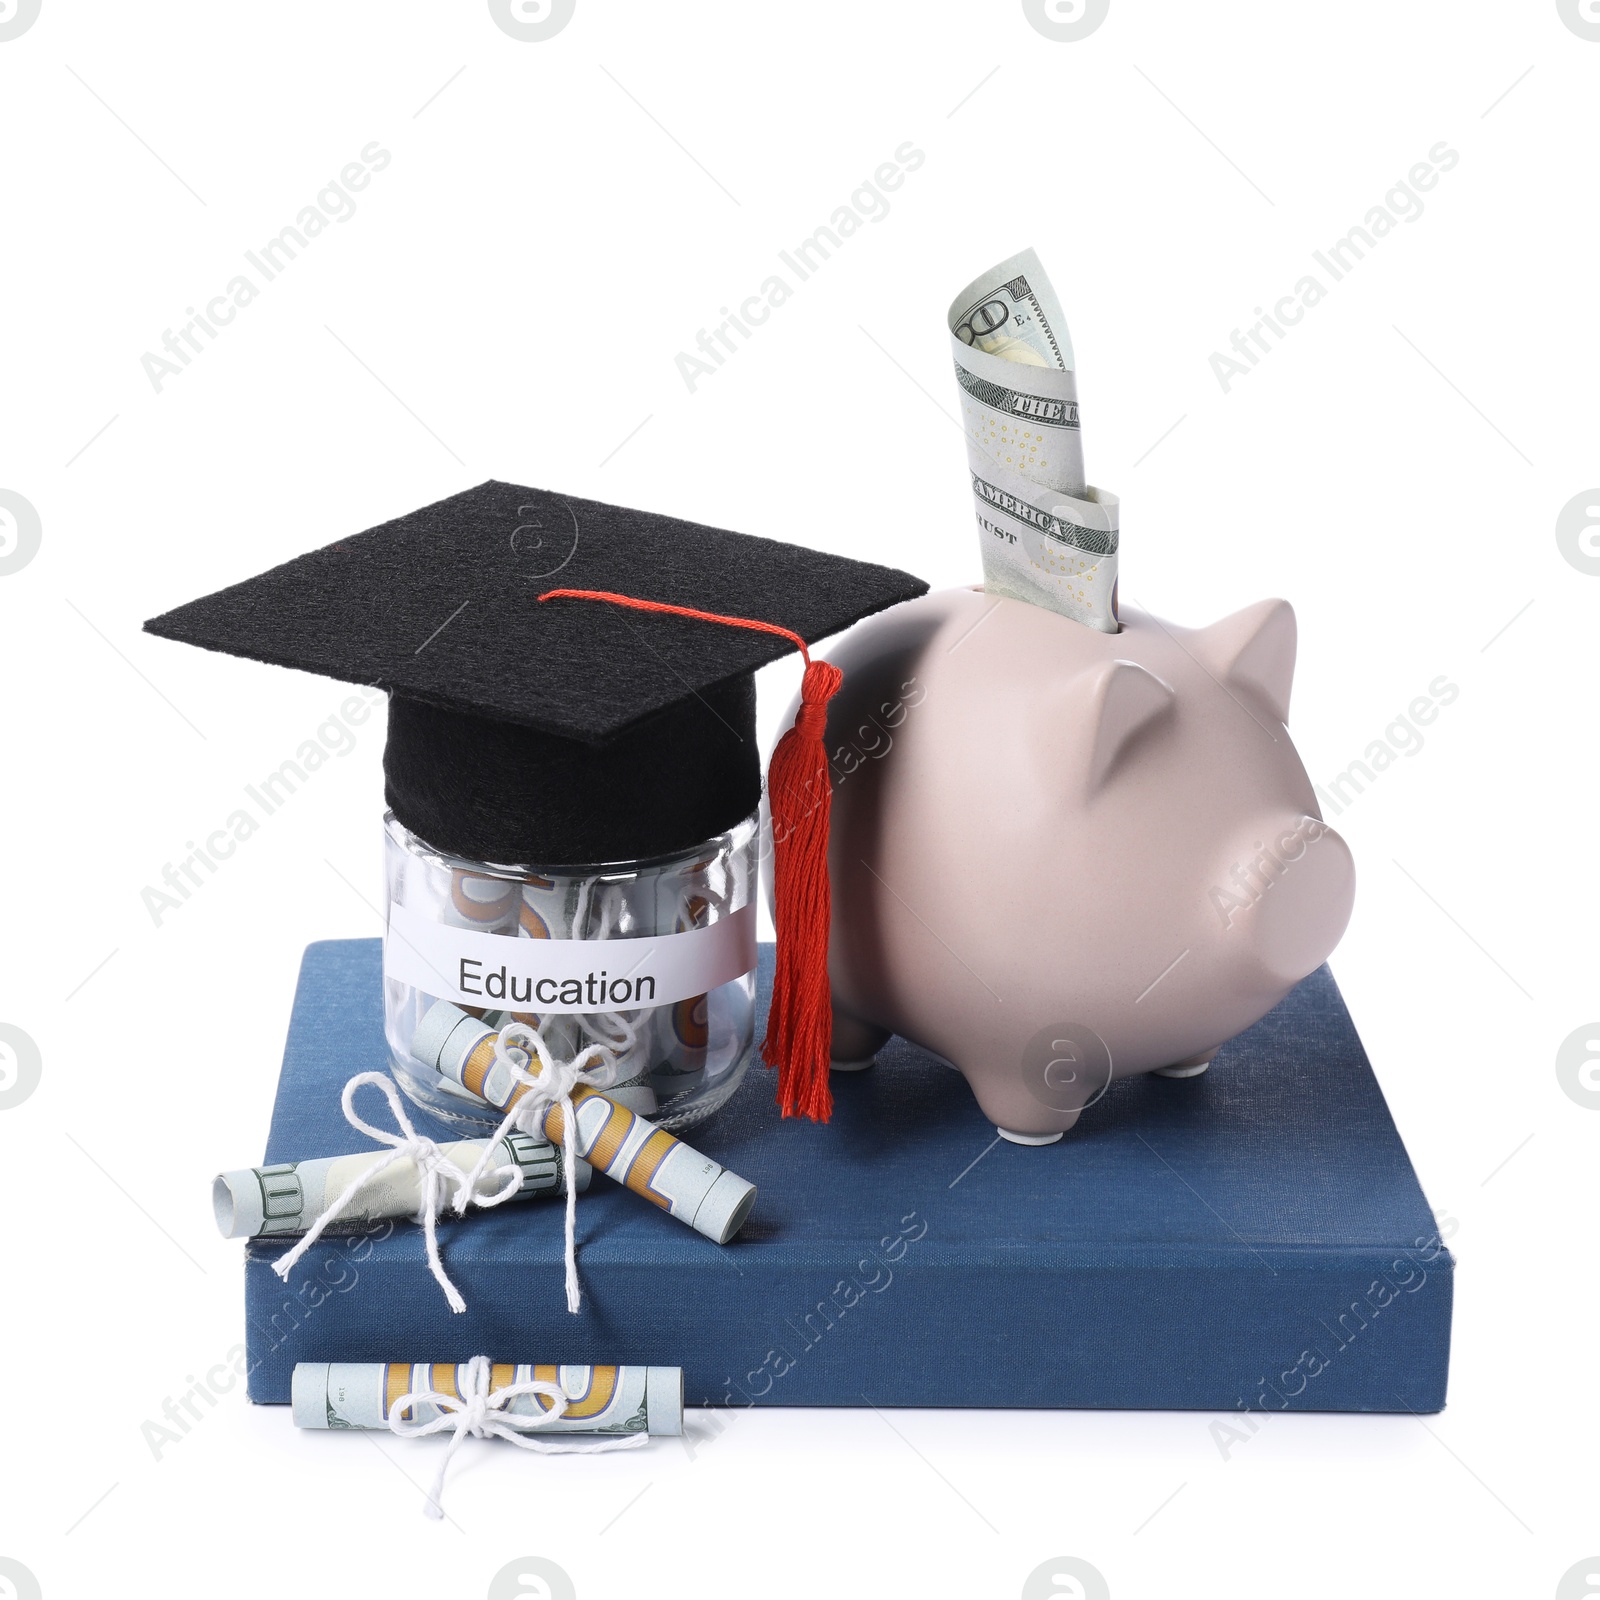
[{"left": 539, "top": 589, "right": 845, "bottom": 1122}]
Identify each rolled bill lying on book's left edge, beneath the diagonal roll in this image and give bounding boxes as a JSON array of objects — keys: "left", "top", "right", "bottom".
[{"left": 211, "top": 1130, "right": 589, "bottom": 1238}]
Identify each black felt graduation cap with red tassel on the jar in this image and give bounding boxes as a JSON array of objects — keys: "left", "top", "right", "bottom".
[{"left": 144, "top": 482, "right": 928, "bottom": 1117}]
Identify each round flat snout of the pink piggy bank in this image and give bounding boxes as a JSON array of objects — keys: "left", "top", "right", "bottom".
[{"left": 1211, "top": 816, "right": 1355, "bottom": 984}]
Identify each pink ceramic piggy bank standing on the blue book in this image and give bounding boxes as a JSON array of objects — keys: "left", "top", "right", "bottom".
[{"left": 812, "top": 589, "right": 1355, "bottom": 1144}]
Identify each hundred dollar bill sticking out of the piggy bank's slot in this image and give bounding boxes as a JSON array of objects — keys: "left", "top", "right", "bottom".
[{"left": 949, "top": 250, "right": 1118, "bottom": 634}]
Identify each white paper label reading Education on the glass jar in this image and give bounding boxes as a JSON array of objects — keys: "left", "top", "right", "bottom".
[{"left": 384, "top": 906, "right": 755, "bottom": 1014}]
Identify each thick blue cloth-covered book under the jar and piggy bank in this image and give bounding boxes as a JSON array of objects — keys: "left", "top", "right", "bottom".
[{"left": 245, "top": 939, "right": 1454, "bottom": 1413}]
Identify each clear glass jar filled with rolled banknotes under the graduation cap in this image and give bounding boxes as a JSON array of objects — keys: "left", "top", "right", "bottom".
[{"left": 384, "top": 813, "right": 758, "bottom": 1136}]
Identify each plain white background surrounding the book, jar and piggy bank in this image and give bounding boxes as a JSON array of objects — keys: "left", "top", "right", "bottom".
[{"left": 0, "top": 0, "right": 1600, "bottom": 1600}]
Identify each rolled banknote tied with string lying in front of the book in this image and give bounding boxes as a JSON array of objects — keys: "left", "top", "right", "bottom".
[{"left": 290, "top": 1362, "right": 683, "bottom": 1434}]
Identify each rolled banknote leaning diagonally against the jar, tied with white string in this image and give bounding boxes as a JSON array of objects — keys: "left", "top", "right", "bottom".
[{"left": 411, "top": 1000, "right": 755, "bottom": 1245}]
